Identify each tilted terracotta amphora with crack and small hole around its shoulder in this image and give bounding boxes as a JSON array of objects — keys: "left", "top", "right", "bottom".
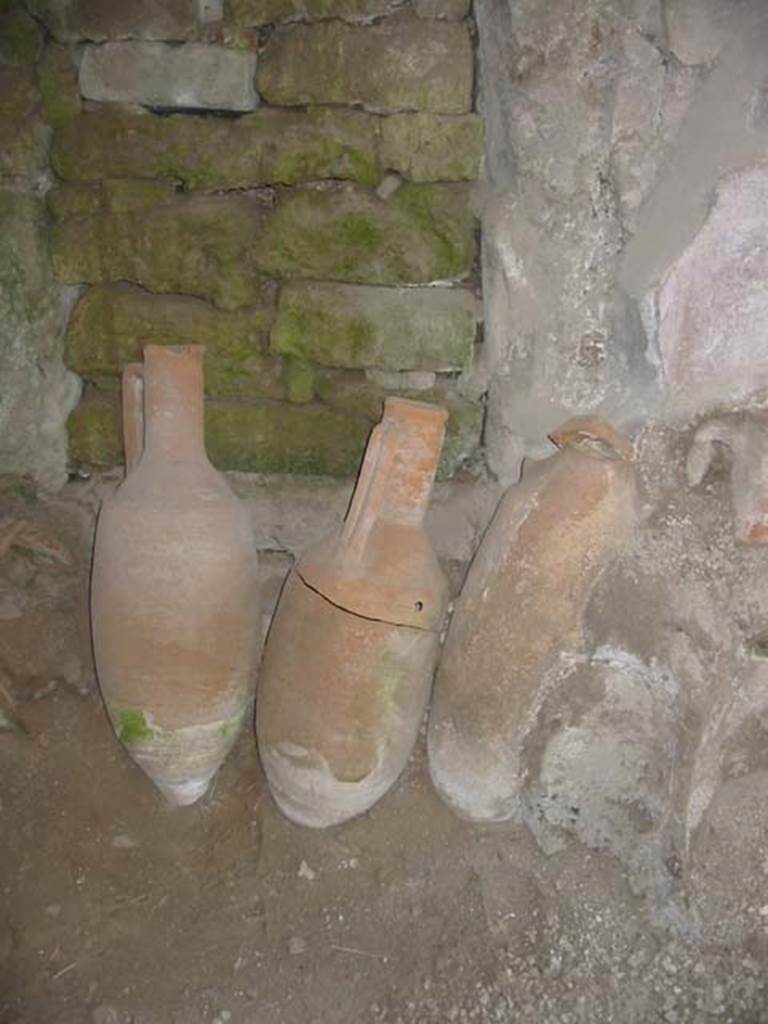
[{"left": 256, "top": 398, "right": 447, "bottom": 827}]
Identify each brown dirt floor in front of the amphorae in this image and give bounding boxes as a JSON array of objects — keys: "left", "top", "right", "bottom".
[{"left": 0, "top": 458, "right": 768, "bottom": 1024}]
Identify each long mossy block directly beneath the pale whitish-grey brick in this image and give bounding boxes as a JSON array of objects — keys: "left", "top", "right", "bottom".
[{"left": 52, "top": 108, "right": 381, "bottom": 188}]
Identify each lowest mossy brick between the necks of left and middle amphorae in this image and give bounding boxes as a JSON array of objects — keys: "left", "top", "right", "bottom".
[{"left": 206, "top": 401, "right": 371, "bottom": 476}]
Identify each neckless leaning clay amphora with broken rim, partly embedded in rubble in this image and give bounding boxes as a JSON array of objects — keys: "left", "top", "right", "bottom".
[{"left": 428, "top": 418, "right": 634, "bottom": 821}]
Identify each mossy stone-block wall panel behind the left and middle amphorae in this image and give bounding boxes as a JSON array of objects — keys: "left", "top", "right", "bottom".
[{"left": 32, "top": 0, "right": 483, "bottom": 476}]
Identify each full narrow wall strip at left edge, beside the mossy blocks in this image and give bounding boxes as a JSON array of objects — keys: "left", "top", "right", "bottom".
[{"left": 0, "top": 2, "right": 80, "bottom": 487}]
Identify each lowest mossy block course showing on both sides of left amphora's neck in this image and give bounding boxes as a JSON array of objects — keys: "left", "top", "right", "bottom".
[{"left": 69, "top": 394, "right": 371, "bottom": 476}]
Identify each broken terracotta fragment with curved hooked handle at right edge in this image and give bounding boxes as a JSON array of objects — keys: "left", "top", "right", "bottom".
[{"left": 686, "top": 410, "right": 768, "bottom": 545}]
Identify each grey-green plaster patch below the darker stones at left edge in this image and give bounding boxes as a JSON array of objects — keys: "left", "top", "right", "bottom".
[{"left": 0, "top": 191, "right": 80, "bottom": 487}]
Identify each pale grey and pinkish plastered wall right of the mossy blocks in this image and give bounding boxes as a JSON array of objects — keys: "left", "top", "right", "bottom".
[{"left": 475, "top": 0, "right": 768, "bottom": 481}]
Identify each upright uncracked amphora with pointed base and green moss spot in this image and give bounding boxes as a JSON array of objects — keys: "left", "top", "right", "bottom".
[{"left": 91, "top": 345, "right": 259, "bottom": 804}]
